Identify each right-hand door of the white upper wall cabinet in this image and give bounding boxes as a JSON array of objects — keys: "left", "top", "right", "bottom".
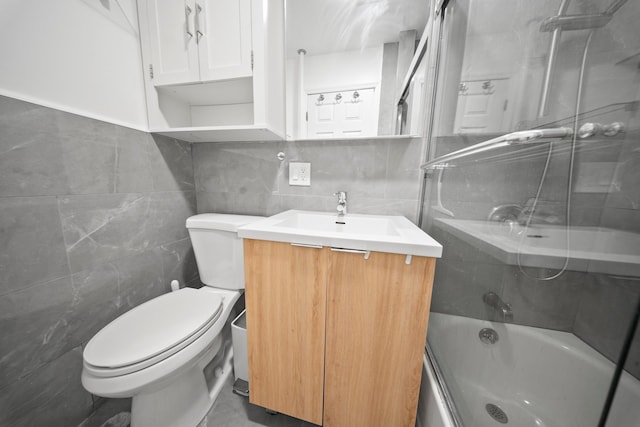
[{"left": 195, "top": 0, "right": 252, "bottom": 82}]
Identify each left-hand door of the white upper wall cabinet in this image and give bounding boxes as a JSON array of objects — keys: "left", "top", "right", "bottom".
[{"left": 145, "top": 0, "right": 199, "bottom": 86}]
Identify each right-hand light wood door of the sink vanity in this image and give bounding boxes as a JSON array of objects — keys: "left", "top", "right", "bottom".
[{"left": 324, "top": 252, "right": 435, "bottom": 427}]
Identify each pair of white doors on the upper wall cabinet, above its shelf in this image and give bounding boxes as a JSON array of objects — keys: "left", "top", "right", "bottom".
[{"left": 141, "top": 0, "right": 252, "bottom": 86}]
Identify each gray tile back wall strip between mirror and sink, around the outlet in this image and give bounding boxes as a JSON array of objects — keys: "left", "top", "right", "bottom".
[{"left": 193, "top": 138, "right": 422, "bottom": 221}]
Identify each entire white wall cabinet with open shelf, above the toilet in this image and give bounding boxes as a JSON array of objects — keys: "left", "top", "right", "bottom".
[{"left": 138, "top": 0, "right": 285, "bottom": 142}]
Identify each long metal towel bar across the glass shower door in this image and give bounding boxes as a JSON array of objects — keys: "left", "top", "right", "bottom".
[{"left": 420, "top": 127, "right": 573, "bottom": 169}]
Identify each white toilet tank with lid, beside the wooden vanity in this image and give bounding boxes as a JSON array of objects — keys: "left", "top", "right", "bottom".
[{"left": 187, "top": 213, "right": 264, "bottom": 289}]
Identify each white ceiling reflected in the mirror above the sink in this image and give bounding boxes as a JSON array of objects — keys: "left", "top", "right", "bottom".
[{"left": 286, "top": 0, "right": 429, "bottom": 58}]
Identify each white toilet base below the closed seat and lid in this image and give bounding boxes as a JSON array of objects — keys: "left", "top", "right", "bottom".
[{"left": 131, "top": 340, "right": 233, "bottom": 427}]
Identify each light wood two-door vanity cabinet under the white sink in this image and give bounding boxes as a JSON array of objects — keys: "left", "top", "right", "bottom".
[{"left": 245, "top": 239, "right": 435, "bottom": 427}]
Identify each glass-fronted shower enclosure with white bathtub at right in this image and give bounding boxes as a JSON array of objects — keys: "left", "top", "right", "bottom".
[{"left": 420, "top": 0, "right": 640, "bottom": 427}]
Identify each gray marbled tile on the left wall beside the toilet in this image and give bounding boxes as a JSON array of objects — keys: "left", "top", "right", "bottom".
[{"left": 0, "top": 97, "right": 198, "bottom": 427}]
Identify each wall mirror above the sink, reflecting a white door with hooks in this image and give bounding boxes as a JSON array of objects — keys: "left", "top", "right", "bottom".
[{"left": 285, "top": 0, "right": 429, "bottom": 139}]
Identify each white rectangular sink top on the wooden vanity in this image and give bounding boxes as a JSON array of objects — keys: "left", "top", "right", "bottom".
[{"left": 238, "top": 210, "right": 442, "bottom": 258}]
